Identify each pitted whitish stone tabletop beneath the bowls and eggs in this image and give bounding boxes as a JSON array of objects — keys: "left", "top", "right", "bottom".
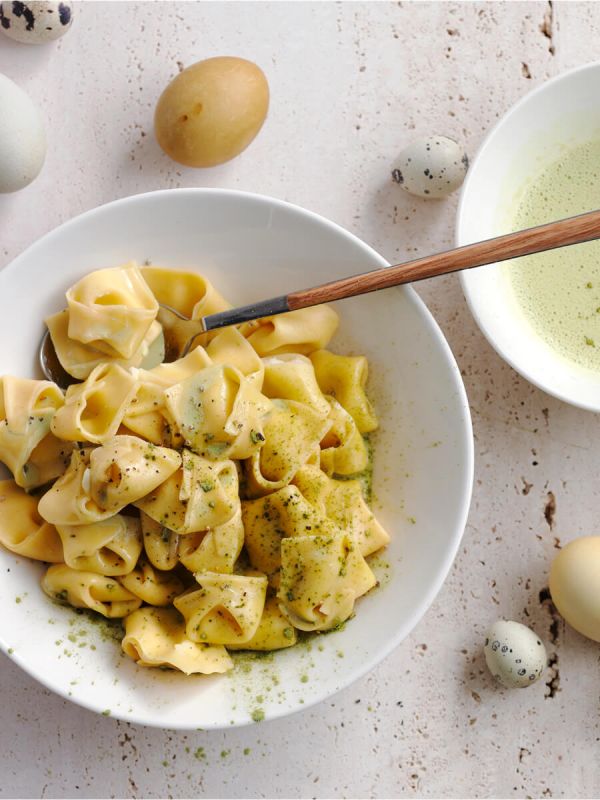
[{"left": 0, "top": 2, "right": 600, "bottom": 797}]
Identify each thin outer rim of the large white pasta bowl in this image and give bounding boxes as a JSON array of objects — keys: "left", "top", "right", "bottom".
[{"left": 0, "top": 187, "right": 474, "bottom": 730}]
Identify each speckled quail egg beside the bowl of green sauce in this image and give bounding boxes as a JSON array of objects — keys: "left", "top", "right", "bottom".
[{"left": 392, "top": 136, "right": 469, "bottom": 198}]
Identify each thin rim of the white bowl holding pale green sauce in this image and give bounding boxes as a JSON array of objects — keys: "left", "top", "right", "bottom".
[{"left": 454, "top": 60, "right": 600, "bottom": 412}]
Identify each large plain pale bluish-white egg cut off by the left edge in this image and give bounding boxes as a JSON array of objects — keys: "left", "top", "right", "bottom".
[{"left": 0, "top": 74, "right": 46, "bottom": 193}]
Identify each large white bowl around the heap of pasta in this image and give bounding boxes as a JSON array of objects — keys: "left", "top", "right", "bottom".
[{"left": 0, "top": 189, "right": 473, "bottom": 729}]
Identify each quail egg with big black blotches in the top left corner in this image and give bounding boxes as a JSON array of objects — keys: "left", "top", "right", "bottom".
[{"left": 0, "top": 0, "right": 73, "bottom": 44}]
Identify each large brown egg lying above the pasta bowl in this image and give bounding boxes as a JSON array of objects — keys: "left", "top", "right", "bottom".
[{"left": 154, "top": 56, "right": 269, "bottom": 167}]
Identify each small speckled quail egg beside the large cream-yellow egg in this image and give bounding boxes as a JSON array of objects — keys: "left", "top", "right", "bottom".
[{"left": 483, "top": 620, "right": 547, "bottom": 689}]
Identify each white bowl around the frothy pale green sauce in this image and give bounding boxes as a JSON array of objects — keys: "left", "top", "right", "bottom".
[{"left": 456, "top": 63, "right": 600, "bottom": 411}]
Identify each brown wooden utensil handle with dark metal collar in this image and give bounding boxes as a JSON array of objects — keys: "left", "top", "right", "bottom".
[{"left": 203, "top": 211, "right": 600, "bottom": 331}]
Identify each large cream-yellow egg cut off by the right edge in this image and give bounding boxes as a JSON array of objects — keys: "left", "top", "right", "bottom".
[{"left": 549, "top": 536, "right": 600, "bottom": 642}]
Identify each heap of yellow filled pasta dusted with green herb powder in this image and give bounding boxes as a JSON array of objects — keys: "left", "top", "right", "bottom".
[{"left": 0, "top": 262, "right": 389, "bottom": 675}]
